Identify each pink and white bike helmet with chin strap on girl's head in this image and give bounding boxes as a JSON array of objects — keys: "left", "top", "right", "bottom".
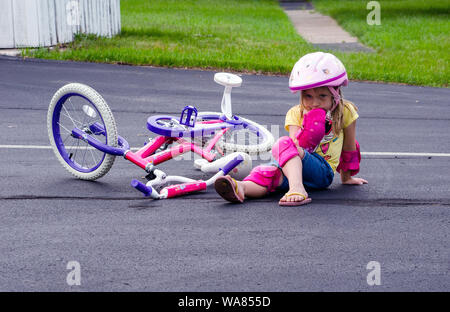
[{"left": 289, "top": 52, "right": 348, "bottom": 110}]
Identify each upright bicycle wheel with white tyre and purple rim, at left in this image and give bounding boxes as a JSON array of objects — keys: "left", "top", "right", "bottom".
[{"left": 47, "top": 83, "right": 118, "bottom": 180}]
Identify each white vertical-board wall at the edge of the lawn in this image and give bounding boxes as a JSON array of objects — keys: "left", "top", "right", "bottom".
[{"left": 0, "top": 0, "right": 120, "bottom": 48}]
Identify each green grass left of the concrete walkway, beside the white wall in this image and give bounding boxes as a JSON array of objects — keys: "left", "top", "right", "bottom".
[{"left": 28, "top": 0, "right": 313, "bottom": 73}]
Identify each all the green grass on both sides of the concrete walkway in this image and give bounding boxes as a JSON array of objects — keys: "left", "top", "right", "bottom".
[{"left": 24, "top": 0, "right": 450, "bottom": 86}]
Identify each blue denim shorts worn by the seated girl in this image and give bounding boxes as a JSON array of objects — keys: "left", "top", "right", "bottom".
[{"left": 270, "top": 151, "right": 334, "bottom": 191}]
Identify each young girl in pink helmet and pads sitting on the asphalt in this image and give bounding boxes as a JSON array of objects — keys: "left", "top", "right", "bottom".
[{"left": 214, "top": 52, "right": 368, "bottom": 206}]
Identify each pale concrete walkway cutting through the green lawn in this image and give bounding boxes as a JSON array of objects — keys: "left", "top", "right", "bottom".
[{"left": 280, "top": 0, "right": 374, "bottom": 52}]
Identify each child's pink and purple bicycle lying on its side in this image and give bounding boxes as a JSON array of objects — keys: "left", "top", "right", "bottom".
[{"left": 47, "top": 73, "right": 274, "bottom": 199}]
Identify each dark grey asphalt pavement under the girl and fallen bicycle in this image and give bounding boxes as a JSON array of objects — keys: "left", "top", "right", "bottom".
[{"left": 0, "top": 57, "right": 450, "bottom": 292}]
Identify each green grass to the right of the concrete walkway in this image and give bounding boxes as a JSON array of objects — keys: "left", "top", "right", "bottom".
[{"left": 313, "top": 0, "right": 450, "bottom": 87}]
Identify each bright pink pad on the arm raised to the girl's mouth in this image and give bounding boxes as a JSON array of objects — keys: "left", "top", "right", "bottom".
[{"left": 296, "top": 108, "right": 327, "bottom": 153}]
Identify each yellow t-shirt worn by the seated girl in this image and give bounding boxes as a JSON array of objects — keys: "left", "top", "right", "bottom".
[{"left": 284, "top": 100, "right": 359, "bottom": 172}]
